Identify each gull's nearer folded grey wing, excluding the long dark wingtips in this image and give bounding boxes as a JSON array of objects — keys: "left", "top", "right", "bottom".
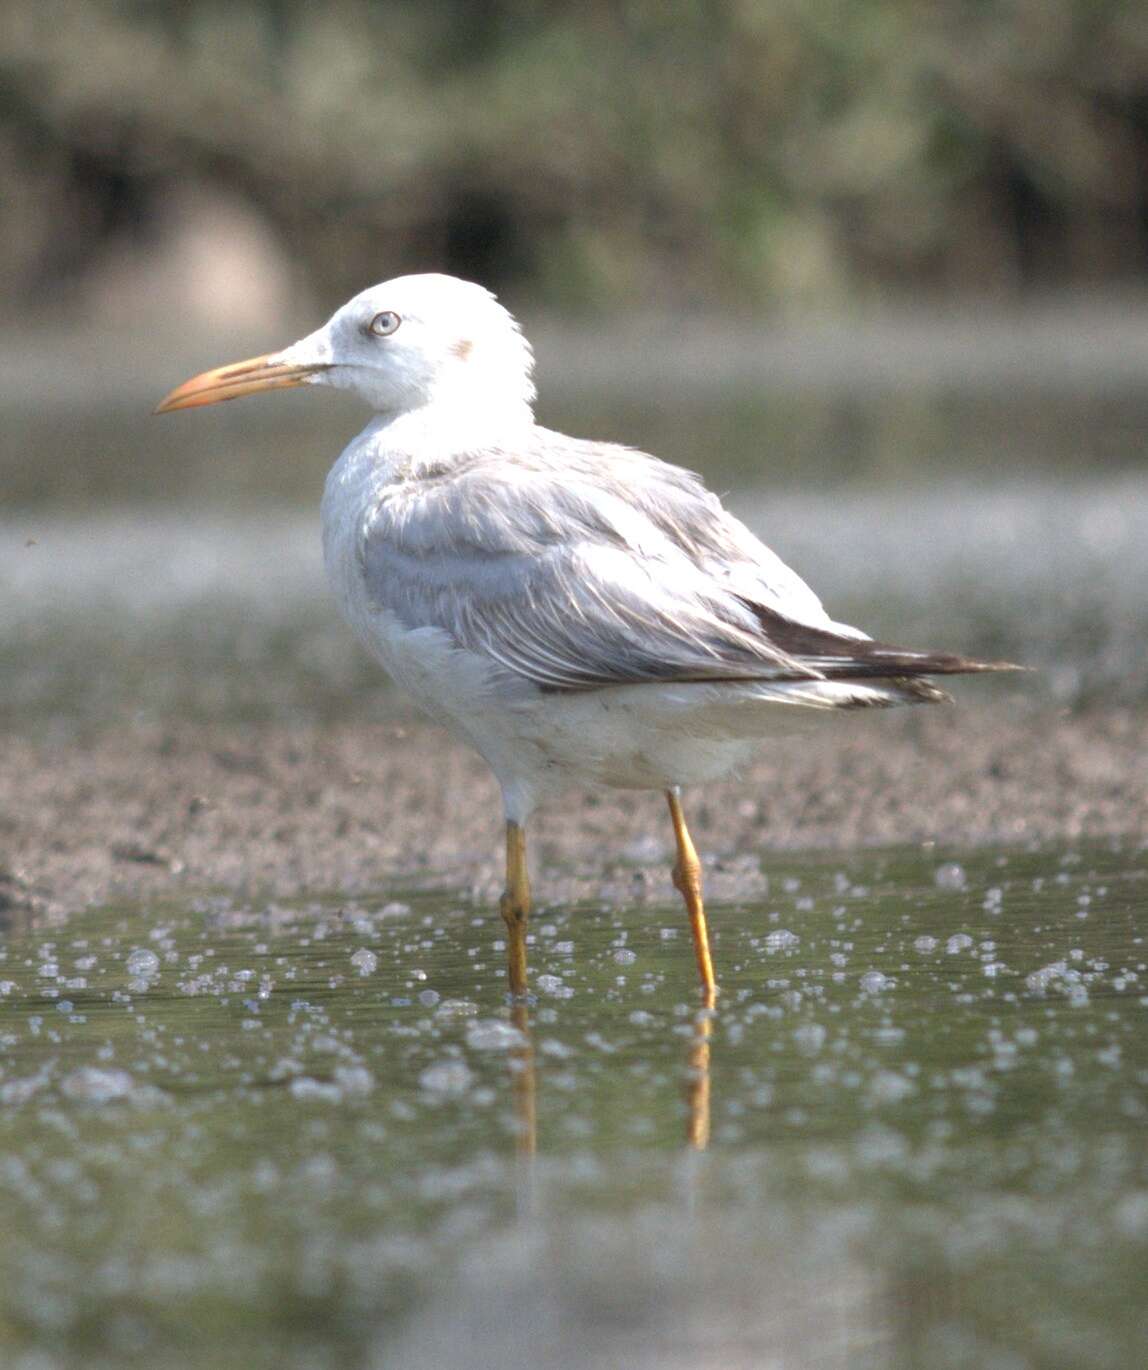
[{"left": 359, "top": 464, "right": 818, "bottom": 690}]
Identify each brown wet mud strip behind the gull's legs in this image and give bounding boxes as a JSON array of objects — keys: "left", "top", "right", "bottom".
[{"left": 0, "top": 696, "right": 1148, "bottom": 915}]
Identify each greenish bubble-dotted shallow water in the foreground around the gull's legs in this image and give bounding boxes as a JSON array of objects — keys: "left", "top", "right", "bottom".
[{"left": 0, "top": 849, "right": 1148, "bottom": 1370}]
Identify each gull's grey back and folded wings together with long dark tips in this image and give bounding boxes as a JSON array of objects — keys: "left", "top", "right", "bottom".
[{"left": 359, "top": 443, "right": 1008, "bottom": 690}]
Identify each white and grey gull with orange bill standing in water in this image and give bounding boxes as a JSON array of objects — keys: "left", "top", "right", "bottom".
[{"left": 156, "top": 274, "right": 1012, "bottom": 1008}]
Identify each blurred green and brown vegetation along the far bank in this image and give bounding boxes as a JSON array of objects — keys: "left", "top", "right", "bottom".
[{"left": 0, "top": 0, "right": 1148, "bottom": 310}]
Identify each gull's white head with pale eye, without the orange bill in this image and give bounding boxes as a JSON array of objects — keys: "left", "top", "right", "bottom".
[{"left": 276, "top": 274, "right": 534, "bottom": 418}]
